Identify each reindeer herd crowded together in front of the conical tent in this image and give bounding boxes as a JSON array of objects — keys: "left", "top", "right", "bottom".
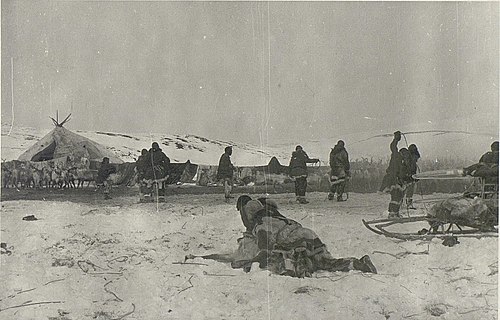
[{"left": 2, "top": 159, "right": 97, "bottom": 189}]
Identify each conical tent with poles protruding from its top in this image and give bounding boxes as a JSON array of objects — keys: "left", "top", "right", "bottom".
[{"left": 19, "top": 114, "right": 123, "bottom": 163}]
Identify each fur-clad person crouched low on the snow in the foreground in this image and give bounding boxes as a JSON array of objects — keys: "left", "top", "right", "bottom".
[{"left": 186, "top": 195, "right": 377, "bottom": 278}]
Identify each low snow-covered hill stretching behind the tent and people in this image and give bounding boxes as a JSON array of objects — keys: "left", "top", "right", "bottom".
[{"left": 1, "top": 124, "right": 498, "bottom": 166}]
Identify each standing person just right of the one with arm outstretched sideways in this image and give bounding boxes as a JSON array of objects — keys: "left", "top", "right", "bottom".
[{"left": 328, "top": 140, "right": 351, "bottom": 201}]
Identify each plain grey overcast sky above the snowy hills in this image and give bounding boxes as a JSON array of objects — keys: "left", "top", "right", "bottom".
[{"left": 1, "top": 0, "right": 499, "bottom": 144}]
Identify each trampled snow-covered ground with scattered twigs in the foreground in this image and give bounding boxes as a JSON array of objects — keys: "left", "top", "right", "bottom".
[{"left": 0, "top": 193, "right": 498, "bottom": 320}]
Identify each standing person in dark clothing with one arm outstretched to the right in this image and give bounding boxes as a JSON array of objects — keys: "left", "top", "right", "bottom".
[{"left": 289, "top": 146, "right": 319, "bottom": 204}]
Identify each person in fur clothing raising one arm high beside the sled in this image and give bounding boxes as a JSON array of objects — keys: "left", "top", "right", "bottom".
[{"left": 380, "top": 131, "right": 410, "bottom": 219}]
